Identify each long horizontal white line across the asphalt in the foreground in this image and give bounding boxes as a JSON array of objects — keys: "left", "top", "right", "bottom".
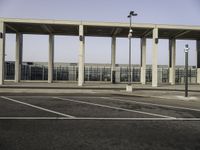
[{"left": 0, "top": 117, "right": 200, "bottom": 121}]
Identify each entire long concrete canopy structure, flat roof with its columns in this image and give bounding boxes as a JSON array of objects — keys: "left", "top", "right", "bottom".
[{"left": 0, "top": 18, "right": 200, "bottom": 86}]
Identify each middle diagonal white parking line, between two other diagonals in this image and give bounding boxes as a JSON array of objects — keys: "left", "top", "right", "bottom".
[{"left": 53, "top": 97, "right": 175, "bottom": 118}]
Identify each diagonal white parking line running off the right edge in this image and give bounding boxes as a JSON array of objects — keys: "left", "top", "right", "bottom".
[{"left": 100, "top": 97, "right": 200, "bottom": 112}]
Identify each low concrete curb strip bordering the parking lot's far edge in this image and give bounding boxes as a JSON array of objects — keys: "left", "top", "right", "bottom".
[{"left": 0, "top": 88, "right": 200, "bottom": 101}]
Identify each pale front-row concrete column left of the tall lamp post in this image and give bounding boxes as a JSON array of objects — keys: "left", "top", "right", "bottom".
[{"left": 78, "top": 25, "right": 85, "bottom": 86}]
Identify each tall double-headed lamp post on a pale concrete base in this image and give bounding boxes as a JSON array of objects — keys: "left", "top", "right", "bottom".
[{"left": 126, "top": 11, "right": 137, "bottom": 91}]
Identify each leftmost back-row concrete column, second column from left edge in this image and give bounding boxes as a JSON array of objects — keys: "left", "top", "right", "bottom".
[{"left": 15, "top": 33, "right": 23, "bottom": 83}]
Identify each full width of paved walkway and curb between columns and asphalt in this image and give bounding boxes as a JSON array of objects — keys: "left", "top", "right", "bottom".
[{"left": 0, "top": 82, "right": 200, "bottom": 101}]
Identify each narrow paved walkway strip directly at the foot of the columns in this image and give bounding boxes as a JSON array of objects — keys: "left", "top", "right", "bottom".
[{"left": 0, "top": 82, "right": 200, "bottom": 92}]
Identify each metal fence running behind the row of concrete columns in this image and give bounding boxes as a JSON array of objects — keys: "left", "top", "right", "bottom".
[{"left": 5, "top": 62, "right": 197, "bottom": 84}]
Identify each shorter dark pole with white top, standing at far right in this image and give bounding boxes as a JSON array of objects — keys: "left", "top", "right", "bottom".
[{"left": 184, "top": 44, "right": 190, "bottom": 97}]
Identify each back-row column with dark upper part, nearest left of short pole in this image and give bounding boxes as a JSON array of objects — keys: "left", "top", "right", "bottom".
[{"left": 169, "top": 39, "right": 176, "bottom": 85}]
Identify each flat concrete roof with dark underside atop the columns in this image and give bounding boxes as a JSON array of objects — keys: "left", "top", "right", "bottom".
[{"left": 0, "top": 18, "right": 200, "bottom": 40}]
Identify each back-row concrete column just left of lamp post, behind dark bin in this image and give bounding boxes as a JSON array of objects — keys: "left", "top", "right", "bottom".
[{"left": 111, "top": 37, "right": 116, "bottom": 83}]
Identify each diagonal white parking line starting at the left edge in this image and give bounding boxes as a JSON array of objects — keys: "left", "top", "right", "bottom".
[{"left": 1, "top": 96, "right": 75, "bottom": 118}]
